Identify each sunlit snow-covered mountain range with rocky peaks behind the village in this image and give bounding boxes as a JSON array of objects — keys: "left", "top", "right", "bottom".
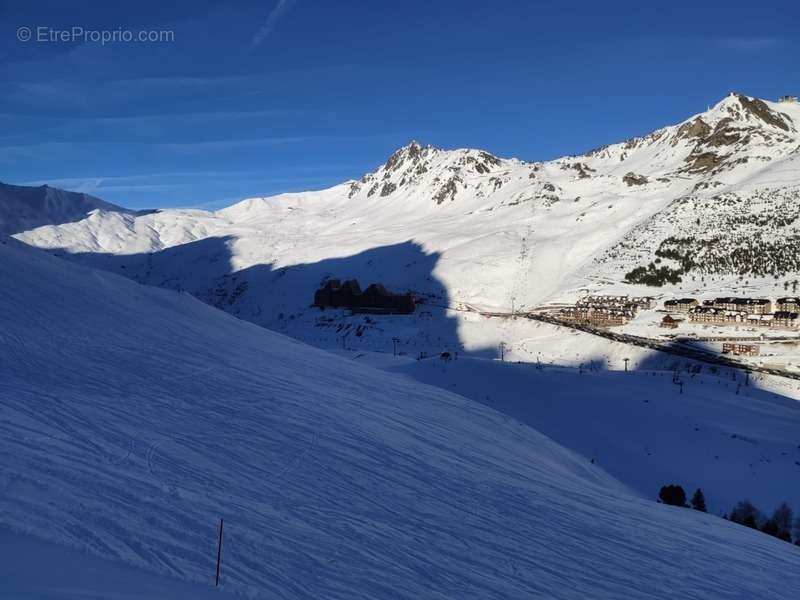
[{"left": 7, "top": 94, "right": 800, "bottom": 310}]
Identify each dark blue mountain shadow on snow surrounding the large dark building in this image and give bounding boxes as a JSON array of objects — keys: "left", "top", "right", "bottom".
[{"left": 56, "top": 236, "right": 497, "bottom": 358}]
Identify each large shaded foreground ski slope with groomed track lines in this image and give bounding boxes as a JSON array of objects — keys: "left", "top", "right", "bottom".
[{"left": 0, "top": 240, "right": 800, "bottom": 599}]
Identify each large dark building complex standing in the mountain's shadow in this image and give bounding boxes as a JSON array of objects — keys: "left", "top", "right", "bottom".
[{"left": 314, "top": 279, "right": 416, "bottom": 315}]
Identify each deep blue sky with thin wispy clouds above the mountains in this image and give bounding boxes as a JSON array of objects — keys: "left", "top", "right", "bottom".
[{"left": 0, "top": 0, "right": 800, "bottom": 208}]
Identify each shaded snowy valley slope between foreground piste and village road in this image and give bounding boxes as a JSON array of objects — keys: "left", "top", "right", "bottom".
[{"left": 354, "top": 353, "right": 800, "bottom": 516}]
